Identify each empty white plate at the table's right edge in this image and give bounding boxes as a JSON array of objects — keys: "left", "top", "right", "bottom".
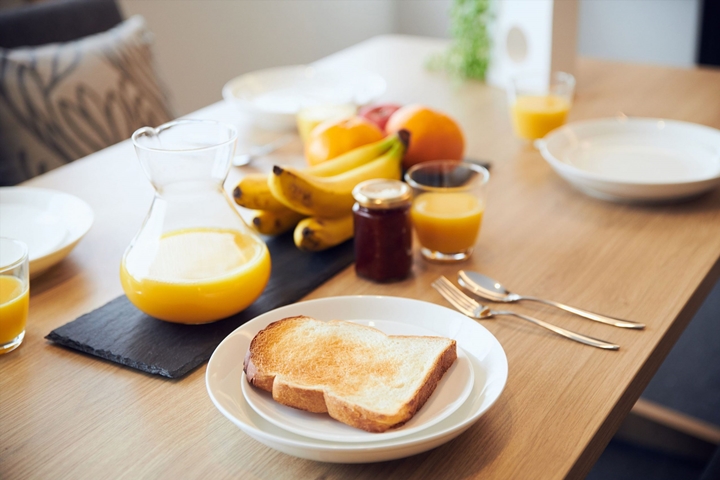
[{"left": 536, "top": 117, "right": 720, "bottom": 202}]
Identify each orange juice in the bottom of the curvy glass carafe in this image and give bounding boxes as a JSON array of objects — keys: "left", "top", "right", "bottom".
[{"left": 120, "top": 228, "right": 270, "bottom": 323}]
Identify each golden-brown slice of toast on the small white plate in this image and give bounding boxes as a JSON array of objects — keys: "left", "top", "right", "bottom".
[{"left": 243, "top": 316, "right": 457, "bottom": 432}]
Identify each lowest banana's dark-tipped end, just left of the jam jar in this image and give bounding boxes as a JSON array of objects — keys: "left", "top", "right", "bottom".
[{"left": 293, "top": 213, "right": 354, "bottom": 252}]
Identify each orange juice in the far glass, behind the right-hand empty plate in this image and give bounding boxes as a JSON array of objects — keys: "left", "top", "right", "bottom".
[{"left": 511, "top": 95, "right": 570, "bottom": 140}]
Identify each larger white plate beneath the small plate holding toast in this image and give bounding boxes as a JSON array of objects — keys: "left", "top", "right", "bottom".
[{"left": 205, "top": 296, "right": 508, "bottom": 463}]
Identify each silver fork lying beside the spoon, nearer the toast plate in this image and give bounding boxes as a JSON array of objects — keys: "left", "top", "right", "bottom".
[{"left": 432, "top": 276, "right": 620, "bottom": 350}]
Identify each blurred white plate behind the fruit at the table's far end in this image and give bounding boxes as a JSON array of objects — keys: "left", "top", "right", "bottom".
[{"left": 222, "top": 65, "right": 386, "bottom": 130}]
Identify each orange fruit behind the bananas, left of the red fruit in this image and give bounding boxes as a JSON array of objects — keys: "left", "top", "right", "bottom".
[{"left": 305, "top": 117, "right": 385, "bottom": 165}]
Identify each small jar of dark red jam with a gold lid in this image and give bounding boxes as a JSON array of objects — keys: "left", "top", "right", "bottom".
[{"left": 353, "top": 179, "right": 412, "bottom": 282}]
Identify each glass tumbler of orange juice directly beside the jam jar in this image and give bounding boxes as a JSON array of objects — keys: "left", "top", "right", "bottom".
[{"left": 405, "top": 160, "right": 490, "bottom": 262}]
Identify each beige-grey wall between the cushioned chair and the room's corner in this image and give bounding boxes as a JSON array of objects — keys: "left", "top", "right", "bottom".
[{"left": 119, "top": 0, "right": 395, "bottom": 114}]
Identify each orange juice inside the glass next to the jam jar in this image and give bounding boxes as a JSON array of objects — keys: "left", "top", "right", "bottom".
[{"left": 410, "top": 192, "right": 484, "bottom": 253}]
